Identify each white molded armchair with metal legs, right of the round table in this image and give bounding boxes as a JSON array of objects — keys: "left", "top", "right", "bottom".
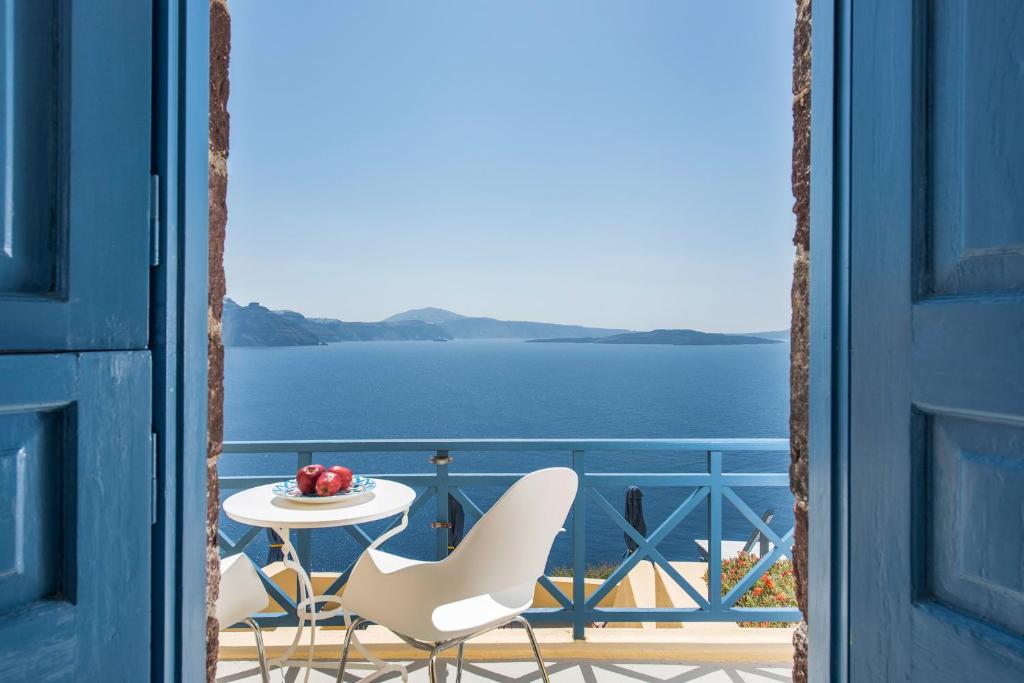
[{"left": 337, "top": 467, "right": 579, "bottom": 683}]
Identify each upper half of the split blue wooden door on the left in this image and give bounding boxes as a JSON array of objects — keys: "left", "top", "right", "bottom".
[{"left": 0, "top": 0, "right": 153, "bottom": 351}]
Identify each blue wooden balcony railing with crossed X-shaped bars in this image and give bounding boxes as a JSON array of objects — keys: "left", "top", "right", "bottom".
[{"left": 219, "top": 438, "right": 801, "bottom": 639}]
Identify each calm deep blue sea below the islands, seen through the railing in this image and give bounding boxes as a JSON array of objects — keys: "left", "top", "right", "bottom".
[{"left": 220, "top": 340, "right": 793, "bottom": 570}]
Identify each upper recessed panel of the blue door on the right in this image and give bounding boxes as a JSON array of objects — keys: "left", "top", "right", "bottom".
[{"left": 921, "top": 0, "right": 1024, "bottom": 294}]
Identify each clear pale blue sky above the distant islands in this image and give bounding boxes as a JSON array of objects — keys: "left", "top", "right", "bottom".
[{"left": 226, "top": 0, "right": 794, "bottom": 331}]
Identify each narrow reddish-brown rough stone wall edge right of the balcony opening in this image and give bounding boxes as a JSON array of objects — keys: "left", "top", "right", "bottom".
[{"left": 790, "top": 0, "right": 811, "bottom": 683}]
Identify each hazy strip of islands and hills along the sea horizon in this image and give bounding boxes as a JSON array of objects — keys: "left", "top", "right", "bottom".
[{"left": 221, "top": 298, "right": 790, "bottom": 346}]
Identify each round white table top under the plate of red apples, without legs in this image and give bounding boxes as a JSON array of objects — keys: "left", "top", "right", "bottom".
[{"left": 224, "top": 479, "right": 416, "bottom": 528}]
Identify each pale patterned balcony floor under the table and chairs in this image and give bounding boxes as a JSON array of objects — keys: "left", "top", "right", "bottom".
[{"left": 217, "top": 661, "right": 792, "bottom": 683}]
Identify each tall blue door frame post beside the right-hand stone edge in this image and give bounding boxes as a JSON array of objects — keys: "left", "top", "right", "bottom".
[{"left": 807, "top": 0, "right": 850, "bottom": 683}]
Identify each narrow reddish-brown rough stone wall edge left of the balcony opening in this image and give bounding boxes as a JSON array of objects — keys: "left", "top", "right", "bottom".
[{"left": 206, "top": 0, "right": 231, "bottom": 683}]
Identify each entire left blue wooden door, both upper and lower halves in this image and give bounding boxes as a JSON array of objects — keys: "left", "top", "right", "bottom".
[{"left": 0, "top": 0, "right": 153, "bottom": 681}]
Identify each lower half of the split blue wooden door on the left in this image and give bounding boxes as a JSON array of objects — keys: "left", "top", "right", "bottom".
[{"left": 0, "top": 351, "right": 152, "bottom": 681}]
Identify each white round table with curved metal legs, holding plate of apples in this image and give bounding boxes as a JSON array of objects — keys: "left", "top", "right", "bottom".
[{"left": 224, "top": 479, "right": 416, "bottom": 681}]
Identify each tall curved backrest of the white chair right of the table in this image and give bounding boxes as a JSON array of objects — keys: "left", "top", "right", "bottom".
[{"left": 445, "top": 467, "right": 579, "bottom": 597}]
